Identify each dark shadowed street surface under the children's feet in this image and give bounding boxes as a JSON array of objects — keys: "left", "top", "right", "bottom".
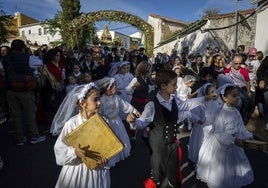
[{"left": 0, "top": 121, "right": 268, "bottom": 188}]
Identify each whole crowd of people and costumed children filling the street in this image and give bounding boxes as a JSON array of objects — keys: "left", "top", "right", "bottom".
[{"left": 0, "top": 39, "right": 268, "bottom": 188}]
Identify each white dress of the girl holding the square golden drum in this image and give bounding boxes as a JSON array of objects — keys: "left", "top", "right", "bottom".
[{"left": 54, "top": 114, "right": 111, "bottom": 188}]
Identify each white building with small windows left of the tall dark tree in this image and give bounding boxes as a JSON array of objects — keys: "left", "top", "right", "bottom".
[{"left": 19, "top": 23, "right": 61, "bottom": 45}]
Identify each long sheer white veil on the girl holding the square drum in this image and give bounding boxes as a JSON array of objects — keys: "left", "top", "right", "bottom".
[{"left": 50, "top": 82, "right": 96, "bottom": 136}]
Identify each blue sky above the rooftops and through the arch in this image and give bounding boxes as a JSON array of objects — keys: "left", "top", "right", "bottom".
[{"left": 0, "top": 0, "right": 254, "bottom": 34}]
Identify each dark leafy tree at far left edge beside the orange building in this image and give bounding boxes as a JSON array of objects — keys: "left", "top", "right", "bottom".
[{"left": 0, "top": 2, "right": 16, "bottom": 44}]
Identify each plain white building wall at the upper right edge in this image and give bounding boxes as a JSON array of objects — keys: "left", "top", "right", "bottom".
[{"left": 255, "top": 7, "right": 268, "bottom": 56}]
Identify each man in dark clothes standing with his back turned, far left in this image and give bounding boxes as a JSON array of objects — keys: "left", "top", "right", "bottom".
[{"left": 7, "top": 39, "right": 46, "bottom": 146}]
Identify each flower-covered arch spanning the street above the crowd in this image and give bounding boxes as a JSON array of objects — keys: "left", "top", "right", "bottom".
[{"left": 70, "top": 10, "right": 154, "bottom": 54}]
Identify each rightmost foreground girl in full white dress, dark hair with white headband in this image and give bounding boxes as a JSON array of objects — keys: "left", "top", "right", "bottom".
[{"left": 197, "top": 85, "right": 254, "bottom": 188}]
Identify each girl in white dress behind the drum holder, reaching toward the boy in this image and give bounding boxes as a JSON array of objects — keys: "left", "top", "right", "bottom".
[{"left": 96, "top": 77, "right": 140, "bottom": 166}]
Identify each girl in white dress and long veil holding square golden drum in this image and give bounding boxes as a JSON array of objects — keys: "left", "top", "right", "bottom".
[{"left": 52, "top": 83, "right": 111, "bottom": 188}]
